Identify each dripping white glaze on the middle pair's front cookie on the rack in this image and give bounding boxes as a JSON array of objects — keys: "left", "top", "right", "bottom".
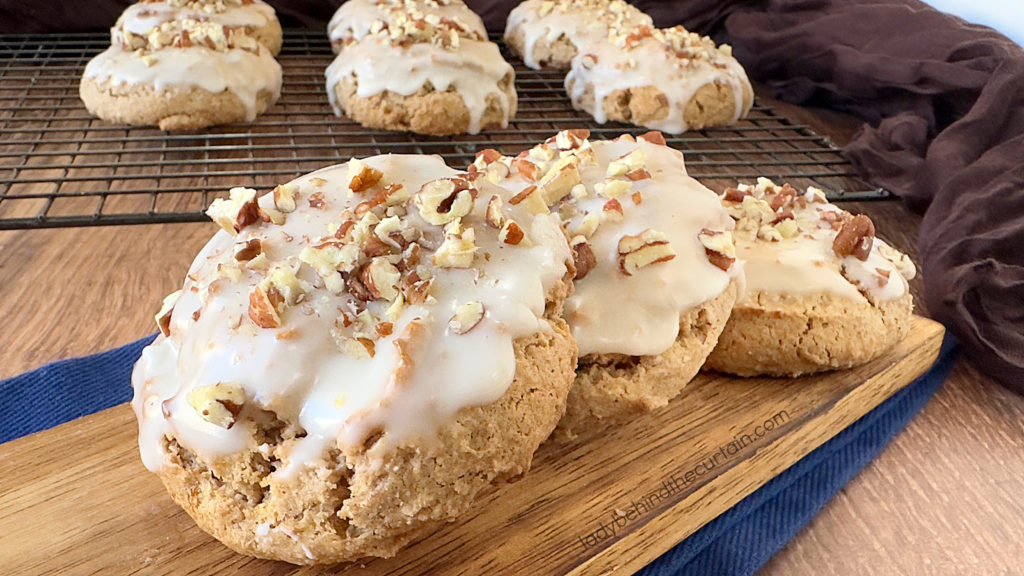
[{"left": 326, "top": 35, "right": 516, "bottom": 134}]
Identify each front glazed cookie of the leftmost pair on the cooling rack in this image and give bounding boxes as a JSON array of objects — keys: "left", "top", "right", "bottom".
[{"left": 79, "top": 19, "right": 282, "bottom": 130}]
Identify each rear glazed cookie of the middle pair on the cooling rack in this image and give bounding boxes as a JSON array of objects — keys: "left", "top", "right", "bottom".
[{"left": 327, "top": 0, "right": 487, "bottom": 53}]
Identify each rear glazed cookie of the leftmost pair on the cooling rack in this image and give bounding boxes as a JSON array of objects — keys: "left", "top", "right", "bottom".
[{"left": 111, "top": 0, "right": 282, "bottom": 55}]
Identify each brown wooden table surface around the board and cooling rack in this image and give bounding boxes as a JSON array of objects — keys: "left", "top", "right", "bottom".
[{"left": 0, "top": 98, "right": 1024, "bottom": 575}]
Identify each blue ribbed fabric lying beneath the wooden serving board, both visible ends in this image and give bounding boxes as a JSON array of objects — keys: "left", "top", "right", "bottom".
[{"left": 0, "top": 335, "right": 957, "bottom": 576}]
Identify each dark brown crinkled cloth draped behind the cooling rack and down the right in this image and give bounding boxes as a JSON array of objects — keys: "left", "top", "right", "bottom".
[{"left": 0, "top": 0, "right": 1024, "bottom": 394}]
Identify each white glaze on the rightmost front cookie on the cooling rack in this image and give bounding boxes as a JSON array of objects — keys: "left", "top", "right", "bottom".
[{"left": 565, "top": 27, "right": 751, "bottom": 134}]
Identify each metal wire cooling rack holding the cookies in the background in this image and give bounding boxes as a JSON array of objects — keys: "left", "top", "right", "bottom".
[{"left": 0, "top": 31, "right": 888, "bottom": 230}]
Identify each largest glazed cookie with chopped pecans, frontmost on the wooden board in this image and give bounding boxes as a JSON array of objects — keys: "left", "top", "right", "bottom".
[{"left": 132, "top": 155, "right": 577, "bottom": 564}]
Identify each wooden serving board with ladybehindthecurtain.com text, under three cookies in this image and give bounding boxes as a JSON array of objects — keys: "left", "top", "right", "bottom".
[{"left": 0, "top": 318, "right": 943, "bottom": 576}]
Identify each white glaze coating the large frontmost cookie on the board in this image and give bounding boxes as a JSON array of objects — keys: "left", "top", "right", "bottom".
[{"left": 132, "top": 156, "right": 571, "bottom": 474}]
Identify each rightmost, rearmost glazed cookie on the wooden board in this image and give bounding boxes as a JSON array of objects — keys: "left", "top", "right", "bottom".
[{"left": 707, "top": 178, "right": 915, "bottom": 376}]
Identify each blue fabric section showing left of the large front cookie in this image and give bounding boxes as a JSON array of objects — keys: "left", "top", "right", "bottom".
[{"left": 0, "top": 334, "right": 157, "bottom": 443}]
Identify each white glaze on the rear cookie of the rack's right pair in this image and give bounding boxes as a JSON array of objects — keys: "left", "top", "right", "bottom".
[{"left": 505, "top": 0, "right": 654, "bottom": 70}]
